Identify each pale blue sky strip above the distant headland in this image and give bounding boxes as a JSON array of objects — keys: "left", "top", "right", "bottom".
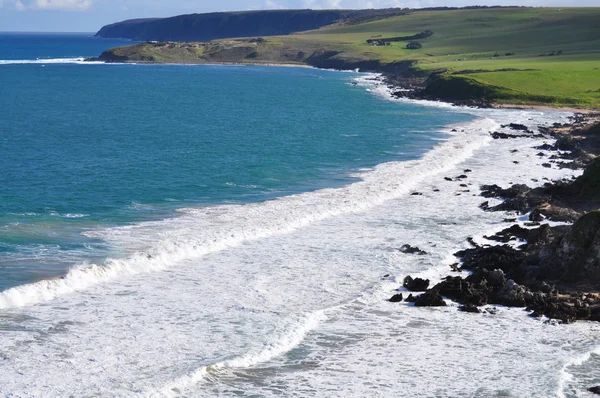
[{"left": 0, "top": 0, "right": 599, "bottom": 32}]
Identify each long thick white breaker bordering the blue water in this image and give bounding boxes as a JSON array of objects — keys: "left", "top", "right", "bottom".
[{"left": 0, "top": 113, "right": 499, "bottom": 309}]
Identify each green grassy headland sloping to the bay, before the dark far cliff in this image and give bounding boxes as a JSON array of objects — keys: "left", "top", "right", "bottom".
[{"left": 95, "top": 7, "right": 600, "bottom": 108}]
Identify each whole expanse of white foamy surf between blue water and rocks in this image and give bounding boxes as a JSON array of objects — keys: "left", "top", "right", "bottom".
[{"left": 0, "top": 71, "right": 600, "bottom": 398}]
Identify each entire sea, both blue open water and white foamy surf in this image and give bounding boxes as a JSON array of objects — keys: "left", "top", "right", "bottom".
[{"left": 0, "top": 33, "right": 600, "bottom": 397}]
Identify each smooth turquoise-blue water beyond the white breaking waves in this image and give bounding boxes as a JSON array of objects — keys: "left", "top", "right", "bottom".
[{"left": 0, "top": 33, "right": 470, "bottom": 289}]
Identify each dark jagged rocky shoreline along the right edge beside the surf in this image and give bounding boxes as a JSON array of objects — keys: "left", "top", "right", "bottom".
[{"left": 390, "top": 109, "right": 600, "bottom": 330}]
